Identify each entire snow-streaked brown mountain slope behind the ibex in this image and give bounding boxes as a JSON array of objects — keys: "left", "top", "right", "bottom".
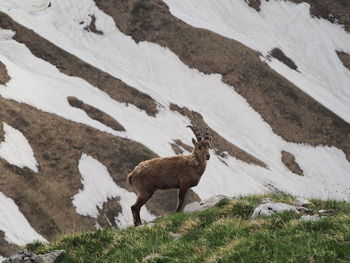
[{"left": 0, "top": 0, "right": 350, "bottom": 256}]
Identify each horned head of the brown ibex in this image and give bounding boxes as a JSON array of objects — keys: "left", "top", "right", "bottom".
[{"left": 187, "top": 125, "right": 212, "bottom": 160}]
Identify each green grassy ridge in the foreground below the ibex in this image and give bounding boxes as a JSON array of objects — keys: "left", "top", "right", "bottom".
[{"left": 27, "top": 194, "right": 350, "bottom": 263}]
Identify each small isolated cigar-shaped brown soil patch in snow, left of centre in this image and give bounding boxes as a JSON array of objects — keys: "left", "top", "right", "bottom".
[{"left": 67, "top": 96, "right": 125, "bottom": 131}]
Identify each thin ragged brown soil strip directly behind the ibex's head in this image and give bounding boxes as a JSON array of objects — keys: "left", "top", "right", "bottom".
[{"left": 170, "top": 104, "right": 266, "bottom": 168}]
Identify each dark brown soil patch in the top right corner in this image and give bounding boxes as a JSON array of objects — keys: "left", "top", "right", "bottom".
[{"left": 289, "top": 0, "right": 350, "bottom": 32}]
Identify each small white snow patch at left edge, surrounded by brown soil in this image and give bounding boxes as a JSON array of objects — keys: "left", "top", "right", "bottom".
[{"left": 0, "top": 123, "right": 38, "bottom": 172}]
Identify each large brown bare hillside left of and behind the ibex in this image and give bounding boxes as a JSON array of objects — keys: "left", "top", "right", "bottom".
[{"left": 0, "top": 97, "right": 198, "bottom": 256}]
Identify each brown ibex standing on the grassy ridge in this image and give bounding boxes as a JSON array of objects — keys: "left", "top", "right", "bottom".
[{"left": 127, "top": 126, "right": 212, "bottom": 226}]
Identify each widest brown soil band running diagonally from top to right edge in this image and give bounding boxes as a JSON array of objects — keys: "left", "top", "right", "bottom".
[{"left": 95, "top": 0, "right": 350, "bottom": 161}]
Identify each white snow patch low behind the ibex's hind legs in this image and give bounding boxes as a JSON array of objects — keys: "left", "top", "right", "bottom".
[{"left": 73, "top": 154, "right": 155, "bottom": 228}]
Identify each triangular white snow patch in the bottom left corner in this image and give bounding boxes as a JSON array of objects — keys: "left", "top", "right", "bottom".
[{"left": 0, "top": 192, "right": 46, "bottom": 246}]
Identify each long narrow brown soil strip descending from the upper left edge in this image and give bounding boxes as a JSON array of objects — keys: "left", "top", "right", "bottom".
[{"left": 0, "top": 12, "right": 157, "bottom": 116}]
